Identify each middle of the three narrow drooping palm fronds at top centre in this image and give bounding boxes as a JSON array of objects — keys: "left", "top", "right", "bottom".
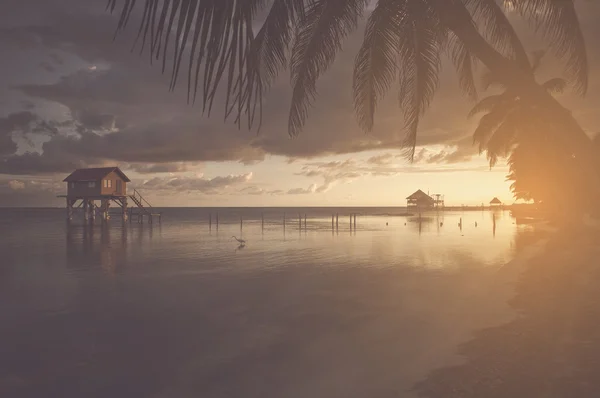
[{"left": 353, "top": 0, "right": 402, "bottom": 132}]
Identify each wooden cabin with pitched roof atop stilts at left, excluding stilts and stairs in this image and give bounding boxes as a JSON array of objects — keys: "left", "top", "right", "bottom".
[{"left": 63, "top": 167, "right": 131, "bottom": 199}]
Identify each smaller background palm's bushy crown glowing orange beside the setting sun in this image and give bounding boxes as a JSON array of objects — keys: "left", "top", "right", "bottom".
[{"left": 469, "top": 51, "right": 567, "bottom": 168}]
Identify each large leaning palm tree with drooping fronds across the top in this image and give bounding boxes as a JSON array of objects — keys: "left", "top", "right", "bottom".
[{"left": 107, "top": 0, "right": 592, "bottom": 164}]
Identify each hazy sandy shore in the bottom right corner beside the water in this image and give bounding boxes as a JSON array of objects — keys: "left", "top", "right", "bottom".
[{"left": 414, "top": 227, "right": 600, "bottom": 398}]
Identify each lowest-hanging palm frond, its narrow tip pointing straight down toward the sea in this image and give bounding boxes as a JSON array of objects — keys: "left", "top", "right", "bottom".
[{"left": 398, "top": 0, "right": 447, "bottom": 161}]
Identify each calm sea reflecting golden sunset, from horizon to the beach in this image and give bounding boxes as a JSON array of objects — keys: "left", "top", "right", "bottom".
[{"left": 0, "top": 208, "right": 533, "bottom": 398}]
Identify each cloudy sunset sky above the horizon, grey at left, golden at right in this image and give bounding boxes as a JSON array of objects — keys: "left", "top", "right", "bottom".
[{"left": 0, "top": 0, "right": 600, "bottom": 206}]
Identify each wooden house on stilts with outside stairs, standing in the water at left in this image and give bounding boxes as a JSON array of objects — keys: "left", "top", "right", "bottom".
[{"left": 60, "top": 167, "right": 161, "bottom": 223}]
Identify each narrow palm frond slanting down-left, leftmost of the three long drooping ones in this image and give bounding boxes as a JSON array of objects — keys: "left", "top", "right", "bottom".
[{"left": 288, "top": 0, "right": 367, "bottom": 136}]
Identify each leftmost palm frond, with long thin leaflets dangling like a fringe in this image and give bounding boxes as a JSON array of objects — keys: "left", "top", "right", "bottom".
[{"left": 107, "top": 0, "right": 265, "bottom": 129}]
